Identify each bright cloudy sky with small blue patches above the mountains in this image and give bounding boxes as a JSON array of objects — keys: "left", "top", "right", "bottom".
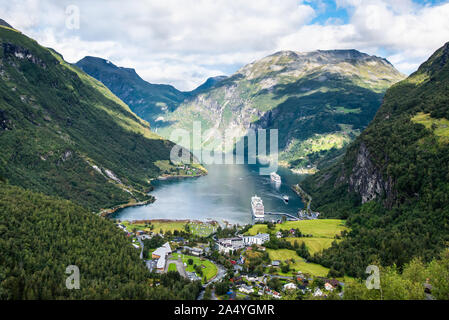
[{"left": 0, "top": 0, "right": 449, "bottom": 90}]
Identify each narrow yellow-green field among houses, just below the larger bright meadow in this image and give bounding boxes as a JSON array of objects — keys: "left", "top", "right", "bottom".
[{"left": 267, "top": 249, "right": 329, "bottom": 277}]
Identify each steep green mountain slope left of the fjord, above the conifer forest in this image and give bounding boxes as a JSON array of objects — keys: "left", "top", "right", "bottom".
[{"left": 0, "top": 27, "right": 185, "bottom": 210}]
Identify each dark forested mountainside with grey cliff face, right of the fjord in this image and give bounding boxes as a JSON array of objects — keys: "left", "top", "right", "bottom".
[{"left": 302, "top": 43, "right": 449, "bottom": 275}]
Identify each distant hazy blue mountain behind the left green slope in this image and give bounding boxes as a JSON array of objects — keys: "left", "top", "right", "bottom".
[{"left": 75, "top": 57, "right": 187, "bottom": 124}]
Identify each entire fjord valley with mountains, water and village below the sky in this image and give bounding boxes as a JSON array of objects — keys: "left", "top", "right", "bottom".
[{"left": 0, "top": 11, "right": 449, "bottom": 300}]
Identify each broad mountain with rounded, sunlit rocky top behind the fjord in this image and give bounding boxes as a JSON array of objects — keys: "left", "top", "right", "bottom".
[{"left": 155, "top": 50, "right": 404, "bottom": 168}]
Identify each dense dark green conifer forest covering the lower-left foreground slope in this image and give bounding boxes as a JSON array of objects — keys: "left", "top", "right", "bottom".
[{"left": 0, "top": 182, "right": 201, "bottom": 299}]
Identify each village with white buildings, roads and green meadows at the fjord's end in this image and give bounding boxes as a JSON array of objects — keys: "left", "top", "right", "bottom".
[{"left": 117, "top": 219, "right": 346, "bottom": 300}]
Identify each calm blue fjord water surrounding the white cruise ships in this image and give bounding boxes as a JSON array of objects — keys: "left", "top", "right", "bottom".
[{"left": 114, "top": 165, "right": 304, "bottom": 225}]
